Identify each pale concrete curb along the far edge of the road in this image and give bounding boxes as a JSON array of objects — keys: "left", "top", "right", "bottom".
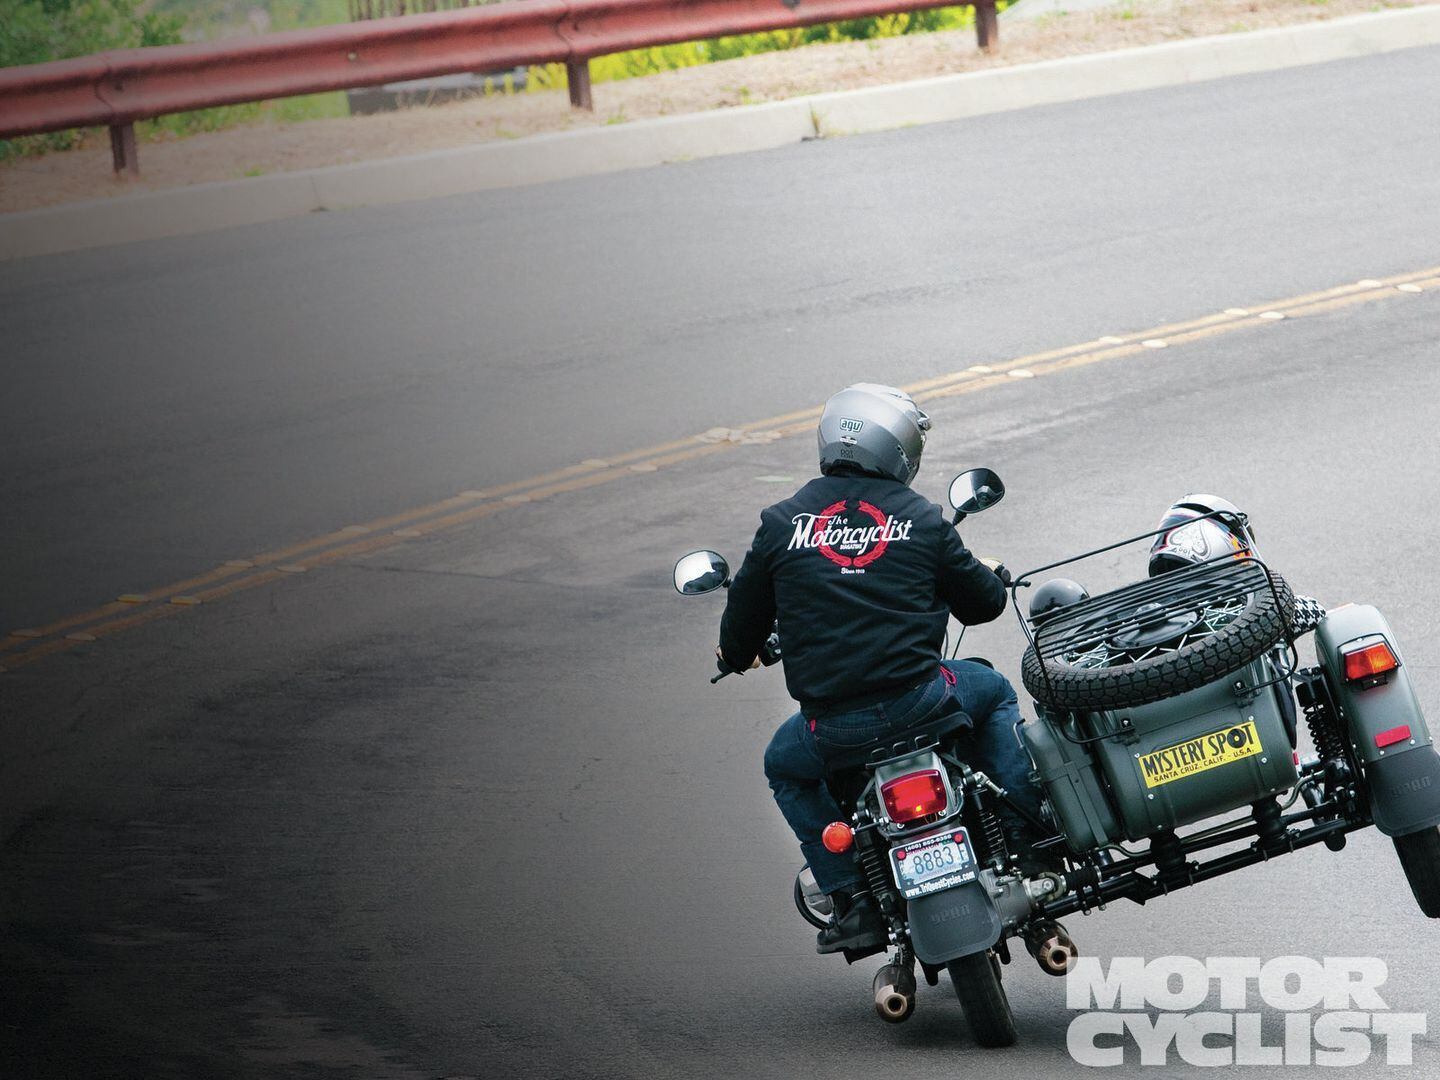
[{"left": 0, "top": 4, "right": 1440, "bottom": 259}]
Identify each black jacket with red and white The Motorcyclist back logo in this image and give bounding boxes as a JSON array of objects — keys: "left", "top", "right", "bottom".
[{"left": 720, "top": 475, "right": 1005, "bottom": 708}]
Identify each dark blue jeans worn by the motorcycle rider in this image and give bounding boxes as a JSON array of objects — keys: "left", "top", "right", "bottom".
[{"left": 765, "top": 660, "right": 1040, "bottom": 893}]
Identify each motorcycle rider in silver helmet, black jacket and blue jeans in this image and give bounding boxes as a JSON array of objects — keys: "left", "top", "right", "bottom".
[{"left": 716, "top": 383, "right": 1040, "bottom": 952}]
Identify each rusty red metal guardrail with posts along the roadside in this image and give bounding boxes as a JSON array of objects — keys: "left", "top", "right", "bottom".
[{"left": 0, "top": 0, "right": 999, "bottom": 174}]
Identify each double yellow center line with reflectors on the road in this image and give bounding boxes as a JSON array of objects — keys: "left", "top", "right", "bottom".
[{"left": 0, "top": 266, "right": 1440, "bottom": 672}]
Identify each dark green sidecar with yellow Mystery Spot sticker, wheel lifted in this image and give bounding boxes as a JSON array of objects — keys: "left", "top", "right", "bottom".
[{"left": 1020, "top": 534, "right": 1440, "bottom": 917}]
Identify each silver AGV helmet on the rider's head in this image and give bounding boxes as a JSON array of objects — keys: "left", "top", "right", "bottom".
[{"left": 819, "top": 383, "right": 930, "bottom": 484}]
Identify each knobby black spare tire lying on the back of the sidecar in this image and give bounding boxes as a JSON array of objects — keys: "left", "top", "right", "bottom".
[{"left": 1020, "top": 572, "right": 1295, "bottom": 713}]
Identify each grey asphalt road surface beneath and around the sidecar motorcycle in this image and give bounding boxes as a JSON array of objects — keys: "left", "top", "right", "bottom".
[{"left": 0, "top": 49, "right": 1440, "bottom": 1077}]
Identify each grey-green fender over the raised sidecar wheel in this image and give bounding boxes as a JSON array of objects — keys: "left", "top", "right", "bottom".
[{"left": 1315, "top": 603, "right": 1440, "bottom": 837}]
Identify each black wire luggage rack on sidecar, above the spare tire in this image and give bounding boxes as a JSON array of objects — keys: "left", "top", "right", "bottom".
[{"left": 1030, "top": 554, "right": 1284, "bottom": 668}]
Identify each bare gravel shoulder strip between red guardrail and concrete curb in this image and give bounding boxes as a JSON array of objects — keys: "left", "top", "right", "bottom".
[{"left": 0, "top": 0, "right": 1426, "bottom": 212}]
